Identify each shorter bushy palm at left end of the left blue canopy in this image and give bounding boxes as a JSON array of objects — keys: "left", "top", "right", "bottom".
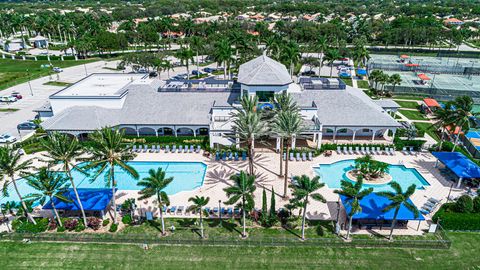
[{"left": 25, "top": 167, "right": 70, "bottom": 227}]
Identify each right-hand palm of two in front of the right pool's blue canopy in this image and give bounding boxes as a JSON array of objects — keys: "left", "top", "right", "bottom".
[{"left": 377, "top": 181, "right": 419, "bottom": 240}]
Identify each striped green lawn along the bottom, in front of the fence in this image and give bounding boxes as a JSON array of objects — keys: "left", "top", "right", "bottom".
[{"left": 0, "top": 233, "right": 480, "bottom": 270}]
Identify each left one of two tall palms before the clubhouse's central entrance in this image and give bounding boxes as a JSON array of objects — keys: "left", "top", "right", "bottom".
[{"left": 233, "top": 95, "right": 267, "bottom": 174}]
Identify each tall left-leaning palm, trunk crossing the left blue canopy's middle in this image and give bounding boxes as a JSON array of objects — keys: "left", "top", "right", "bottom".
[{"left": 42, "top": 132, "right": 87, "bottom": 224}]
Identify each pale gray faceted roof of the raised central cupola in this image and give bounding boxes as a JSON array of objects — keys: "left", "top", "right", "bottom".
[{"left": 238, "top": 55, "right": 292, "bottom": 85}]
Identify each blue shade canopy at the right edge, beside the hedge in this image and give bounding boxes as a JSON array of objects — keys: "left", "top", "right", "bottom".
[{"left": 432, "top": 152, "right": 480, "bottom": 179}]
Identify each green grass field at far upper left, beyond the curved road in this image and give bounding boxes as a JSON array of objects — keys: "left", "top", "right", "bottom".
[{"left": 0, "top": 58, "right": 99, "bottom": 90}]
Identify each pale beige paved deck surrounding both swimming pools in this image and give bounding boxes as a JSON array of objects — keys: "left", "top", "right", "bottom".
[{"left": 0, "top": 149, "right": 464, "bottom": 234}]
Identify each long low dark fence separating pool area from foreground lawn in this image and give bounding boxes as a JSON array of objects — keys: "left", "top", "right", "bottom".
[{"left": 0, "top": 231, "right": 451, "bottom": 249}]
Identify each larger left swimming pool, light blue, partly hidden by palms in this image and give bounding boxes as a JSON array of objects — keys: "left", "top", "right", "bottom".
[{"left": 0, "top": 161, "right": 207, "bottom": 202}]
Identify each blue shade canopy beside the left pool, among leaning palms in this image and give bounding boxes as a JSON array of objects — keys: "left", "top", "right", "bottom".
[{"left": 43, "top": 188, "right": 112, "bottom": 211}]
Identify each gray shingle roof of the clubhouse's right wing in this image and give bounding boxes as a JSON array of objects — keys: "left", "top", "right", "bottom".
[{"left": 292, "top": 87, "right": 400, "bottom": 127}]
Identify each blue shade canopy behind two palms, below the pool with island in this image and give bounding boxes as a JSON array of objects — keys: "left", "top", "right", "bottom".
[{"left": 340, "top": 193, "right": 425, "bottom": 221}]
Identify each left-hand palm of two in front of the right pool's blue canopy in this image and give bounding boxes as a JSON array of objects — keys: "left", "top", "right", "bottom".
[{"left": 333, "top": 177, "right": 373, "bottom": 240}]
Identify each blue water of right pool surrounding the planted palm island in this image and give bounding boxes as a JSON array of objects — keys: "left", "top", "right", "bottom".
[{"left": 314, "top": 160, "right": 430, "bottom": 192}]
